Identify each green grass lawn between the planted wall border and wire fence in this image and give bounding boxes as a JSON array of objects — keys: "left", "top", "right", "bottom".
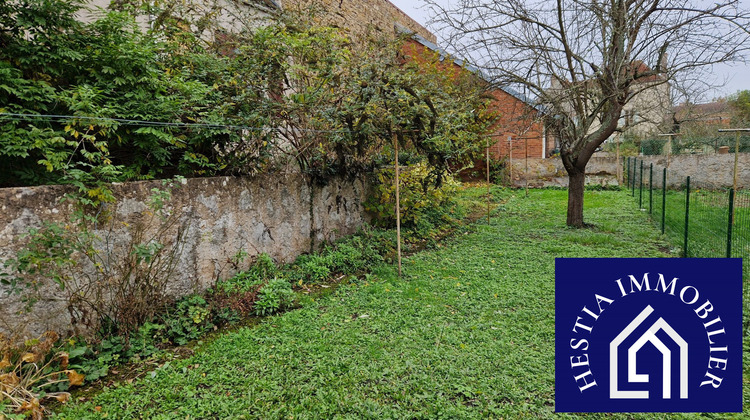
[{"left": 53, "top": 190, "right": 748, "bottom": 419}]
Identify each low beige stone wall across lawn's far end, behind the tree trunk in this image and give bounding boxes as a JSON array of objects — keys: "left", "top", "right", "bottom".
[{"left": 512, "top": 156, "right": 617, "bottom": 188}]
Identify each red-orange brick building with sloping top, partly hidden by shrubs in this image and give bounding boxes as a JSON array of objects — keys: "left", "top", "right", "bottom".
[{"left": 406, "top": 32, "right": 555, "bottom": 159}]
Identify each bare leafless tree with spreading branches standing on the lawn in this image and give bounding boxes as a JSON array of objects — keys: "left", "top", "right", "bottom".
[{"left": 425, "top": 0, "right": 750, "bottom": 227}]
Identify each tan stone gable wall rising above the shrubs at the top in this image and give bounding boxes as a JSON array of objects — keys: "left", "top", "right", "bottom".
[{"left": 282, "top": 0, "right": 436, "bottom": 42}]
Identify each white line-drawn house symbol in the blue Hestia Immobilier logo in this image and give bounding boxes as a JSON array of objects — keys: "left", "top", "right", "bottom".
[{"left": 609, "top": 305, "right": 688, "bottom": 399}]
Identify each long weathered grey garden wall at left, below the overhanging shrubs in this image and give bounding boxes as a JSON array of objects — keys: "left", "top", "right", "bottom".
[{"left": 0, "top": 174, "right": 367, "bottom": 338}]
